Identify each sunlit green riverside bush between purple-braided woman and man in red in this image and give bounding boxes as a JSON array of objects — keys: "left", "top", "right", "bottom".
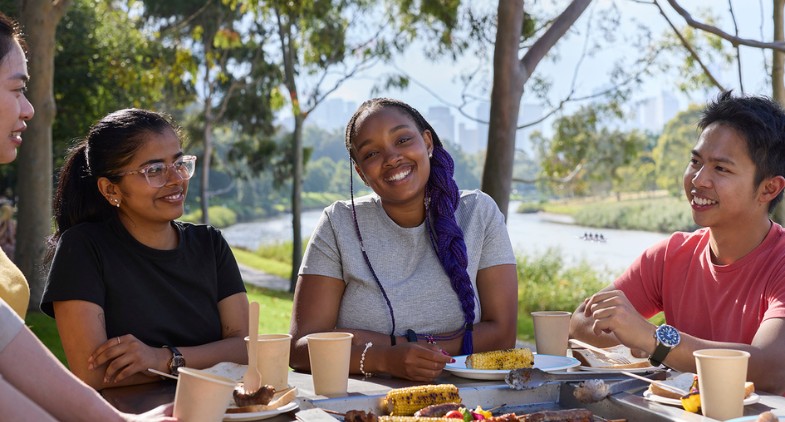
[{"left": 517, "top": 248, "right": 612, "bottom": 339}]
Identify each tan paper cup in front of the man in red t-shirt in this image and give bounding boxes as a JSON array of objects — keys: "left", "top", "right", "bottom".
[{"left": 692, "top": 349, "right": 750, "bottom": 420}]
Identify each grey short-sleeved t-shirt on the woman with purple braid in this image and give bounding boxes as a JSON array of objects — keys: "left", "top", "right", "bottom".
[{"left": 299, "top": 190, "right": 515, "bottom": 335}]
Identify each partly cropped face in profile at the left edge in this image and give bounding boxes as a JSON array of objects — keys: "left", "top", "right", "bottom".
[{"left": 0, "top": 42, "right": 34, "bottom": 164}]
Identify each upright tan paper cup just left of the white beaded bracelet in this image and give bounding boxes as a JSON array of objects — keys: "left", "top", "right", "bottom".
[{"left": 305, "top": 332, "right": 354, "bottom": 397}]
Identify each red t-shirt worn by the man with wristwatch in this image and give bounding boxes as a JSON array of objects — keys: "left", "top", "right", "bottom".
[{"left": 614, "top": 223, "right": 785, "bottom": 344}]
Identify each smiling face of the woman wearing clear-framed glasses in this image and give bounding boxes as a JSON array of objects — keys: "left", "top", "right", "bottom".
[{"left": 104, "top": 129, "right": 188, "bottom": 231}]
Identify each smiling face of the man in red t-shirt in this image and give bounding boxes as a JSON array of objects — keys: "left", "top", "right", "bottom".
[{"left": 684, "top": 122, "right": 778, "bottom": 230}]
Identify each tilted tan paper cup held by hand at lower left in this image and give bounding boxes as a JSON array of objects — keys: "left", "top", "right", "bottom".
[{"left": 173, "top": 368, "right": 237, "bottom": 422}]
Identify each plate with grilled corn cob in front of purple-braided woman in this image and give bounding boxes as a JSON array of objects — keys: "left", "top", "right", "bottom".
[{"left": 444, "top": 348, "right": 580, "bottom": 380}]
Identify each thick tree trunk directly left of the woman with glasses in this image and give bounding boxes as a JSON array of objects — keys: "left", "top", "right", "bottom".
[{"left": 16, "top": 0, "right": 70, "bottom": 311}]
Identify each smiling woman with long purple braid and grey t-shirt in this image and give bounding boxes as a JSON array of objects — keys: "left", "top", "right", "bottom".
[{"left": 290, "top": 98, "right": 518, "bottom": 381}]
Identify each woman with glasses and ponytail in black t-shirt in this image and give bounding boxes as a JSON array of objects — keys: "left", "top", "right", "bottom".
[{"left": 41, "top": 109, "right": 248, "bottom": 389}]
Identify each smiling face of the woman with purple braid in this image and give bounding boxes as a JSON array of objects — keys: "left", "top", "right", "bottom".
[{"left": 351, "top": 106, "right": 433, "bottom": 217}]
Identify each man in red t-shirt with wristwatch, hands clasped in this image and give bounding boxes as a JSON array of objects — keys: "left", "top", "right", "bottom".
[{"left": 570, "top": 92, "right": 785, "bottom": 394}]
